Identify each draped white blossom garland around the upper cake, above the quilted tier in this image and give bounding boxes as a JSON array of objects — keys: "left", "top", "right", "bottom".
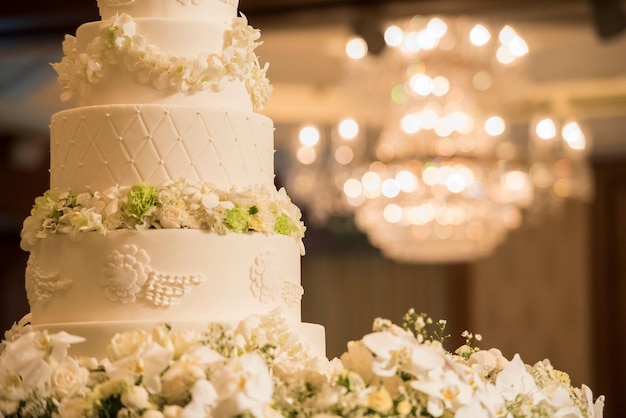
[{"left": 52, "top": 14, "right": 272, "bottom": 110}]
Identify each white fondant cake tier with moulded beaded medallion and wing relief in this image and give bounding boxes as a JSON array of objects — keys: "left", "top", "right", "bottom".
[{"left": 26, "top": 229, "right": 303, "bottom": 326}]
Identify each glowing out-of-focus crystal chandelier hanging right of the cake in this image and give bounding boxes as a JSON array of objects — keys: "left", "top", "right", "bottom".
[{"left": 282, "top": 17, "right": 591, "bottom": 263}]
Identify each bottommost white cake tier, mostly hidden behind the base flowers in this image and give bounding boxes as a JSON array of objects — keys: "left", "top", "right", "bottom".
[{"left": 33, "top": 321, "right": 326, "bottom": 359}]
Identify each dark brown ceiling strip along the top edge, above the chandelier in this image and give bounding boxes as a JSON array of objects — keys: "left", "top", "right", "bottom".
[{"left": 0, "top": 0, "right": 626, "bottom": 46}]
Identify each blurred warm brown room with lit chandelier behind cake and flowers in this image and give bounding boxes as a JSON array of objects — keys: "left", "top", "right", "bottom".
[{"left": 0, "top": 0, "right": 626, "bottom": 417}]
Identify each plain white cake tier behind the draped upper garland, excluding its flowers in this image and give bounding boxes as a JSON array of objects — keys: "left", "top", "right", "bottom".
[{"left": 76, "top": 17, "right": 252, "bottom": 111}]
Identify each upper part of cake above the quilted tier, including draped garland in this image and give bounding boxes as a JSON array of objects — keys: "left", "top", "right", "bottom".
[{"left": 53, "top": 0, "right": 272, "bottom": 111}]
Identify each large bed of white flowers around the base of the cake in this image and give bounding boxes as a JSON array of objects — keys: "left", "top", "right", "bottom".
[{"left": 0, "top": 310, "right": 604, "bottom": 418}]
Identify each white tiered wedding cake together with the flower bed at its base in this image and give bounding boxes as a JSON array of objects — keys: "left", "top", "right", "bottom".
[{"left": 0, "top": 0, "right": 604, "bottom": 418}]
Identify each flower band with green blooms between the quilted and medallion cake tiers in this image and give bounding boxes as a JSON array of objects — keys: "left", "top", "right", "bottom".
[{"left": 21, "top": 179, "right": 306, "bottom": 254}]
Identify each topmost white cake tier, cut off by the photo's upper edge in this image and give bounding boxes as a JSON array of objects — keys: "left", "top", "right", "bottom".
[{"left": 98, "top": 0, "right": 239, "bottom": 19}]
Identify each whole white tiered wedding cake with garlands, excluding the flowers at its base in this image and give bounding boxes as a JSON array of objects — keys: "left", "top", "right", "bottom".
[{"left": 17, "top": 0, "right": 325, "bottom": 356}]
